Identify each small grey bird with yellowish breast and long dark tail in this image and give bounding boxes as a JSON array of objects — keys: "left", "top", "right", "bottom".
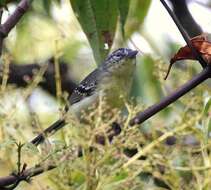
[{"left": 31, "top": 48, "right": 138, "bottom": 144}]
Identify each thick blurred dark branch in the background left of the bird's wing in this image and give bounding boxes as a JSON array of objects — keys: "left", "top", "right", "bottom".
[{"left": 0, "top": 59, "right": 76, "bottom": 96}]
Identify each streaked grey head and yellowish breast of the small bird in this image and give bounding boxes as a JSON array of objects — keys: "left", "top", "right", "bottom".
[{"left": 99, "top": 48, "right": 138, "bottom": 108}]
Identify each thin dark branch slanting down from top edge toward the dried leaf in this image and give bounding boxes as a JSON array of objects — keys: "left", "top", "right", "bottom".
[{"left": 160, "top": 0, "right": 207, "bottom": 68}]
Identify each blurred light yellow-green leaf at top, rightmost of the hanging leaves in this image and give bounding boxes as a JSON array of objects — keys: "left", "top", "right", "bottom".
[{"left": 125, "top": 0, "right": 151, "bottom": 37}]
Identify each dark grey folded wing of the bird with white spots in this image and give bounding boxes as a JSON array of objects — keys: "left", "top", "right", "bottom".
[{"left": 70, "top": 69, "right": 100, "bottom": 105}]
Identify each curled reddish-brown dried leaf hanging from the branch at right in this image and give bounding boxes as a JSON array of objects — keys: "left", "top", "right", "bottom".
[{"left": 164, "top": 34, "right": 211, "bottom": 80}]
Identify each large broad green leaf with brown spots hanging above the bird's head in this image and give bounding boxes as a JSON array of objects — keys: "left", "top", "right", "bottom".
[{"left": 70, "top": 0, "right": 118, "bottom": 64}]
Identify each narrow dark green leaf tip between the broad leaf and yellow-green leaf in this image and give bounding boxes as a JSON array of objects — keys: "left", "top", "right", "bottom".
[{"left": 118, "top": 0, "right": 130, "bottom": 38}]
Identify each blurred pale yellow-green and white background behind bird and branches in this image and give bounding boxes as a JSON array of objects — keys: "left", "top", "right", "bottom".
[{"left": 0, "top": 0, "right": 211, "bottom": 189}]
